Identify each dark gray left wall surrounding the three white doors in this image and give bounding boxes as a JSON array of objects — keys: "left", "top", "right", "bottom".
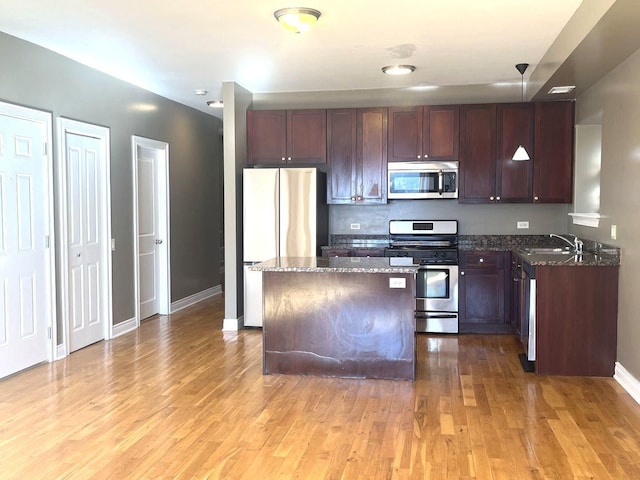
[{"left": 0, "top": 32, "right": 222, "bottom": 323}]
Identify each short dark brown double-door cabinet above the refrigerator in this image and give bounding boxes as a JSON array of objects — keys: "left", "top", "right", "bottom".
[{"left": 247, "top": 110, "right": 327, "bottom": 165}]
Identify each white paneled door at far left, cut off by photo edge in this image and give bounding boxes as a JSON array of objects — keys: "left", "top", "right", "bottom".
[{"left": 0, "top": 103, "right": 55, "bottom": 378}]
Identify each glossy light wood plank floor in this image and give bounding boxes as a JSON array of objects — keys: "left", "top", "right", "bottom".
[{"left": 0, "top": 297, "right": 640, "bottom": 480}]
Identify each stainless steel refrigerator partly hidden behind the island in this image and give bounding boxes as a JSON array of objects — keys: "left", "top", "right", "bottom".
[{"left": 242, "top": 167, "right": 329, "bottom": 327}]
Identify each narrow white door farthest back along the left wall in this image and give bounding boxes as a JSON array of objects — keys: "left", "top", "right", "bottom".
[{"left": 133, "top": 137, "right": 169, "bottom": 319}]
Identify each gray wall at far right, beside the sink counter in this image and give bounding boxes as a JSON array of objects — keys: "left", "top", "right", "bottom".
[{"left": 572, "top": 50, "right": 640, "bottom": 378}]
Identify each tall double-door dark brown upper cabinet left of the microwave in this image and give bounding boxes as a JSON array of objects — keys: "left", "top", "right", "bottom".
[{"left": 327, "top": 108, "right": 387, "bottom": 205}]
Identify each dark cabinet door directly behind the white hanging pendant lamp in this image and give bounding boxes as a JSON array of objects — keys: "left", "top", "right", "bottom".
[{"left": 496, "top": 103, "right": 534, "bottom": 203}]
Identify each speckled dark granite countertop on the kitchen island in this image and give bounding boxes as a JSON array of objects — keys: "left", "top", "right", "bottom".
[{"left": 249, "top": 257, "right": 418, "bottom": 273}]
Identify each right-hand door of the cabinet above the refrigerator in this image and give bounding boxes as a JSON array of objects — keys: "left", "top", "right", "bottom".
[{"left": 287, "top": 110, "right": 327, "bottom": 164}]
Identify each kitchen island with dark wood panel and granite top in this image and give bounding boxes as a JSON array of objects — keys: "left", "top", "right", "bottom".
[{"left": 251, "top": 257, "right": 417, "bottom": 380}]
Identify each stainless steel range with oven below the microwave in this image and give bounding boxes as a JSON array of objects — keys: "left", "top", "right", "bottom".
[{"left": 385, "top": 220, "right": 458, "bottom": 333}]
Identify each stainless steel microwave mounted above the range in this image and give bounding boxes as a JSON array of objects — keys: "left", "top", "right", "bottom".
[{"left": 387, "top": 162, "right": 458, "bottom": 199}]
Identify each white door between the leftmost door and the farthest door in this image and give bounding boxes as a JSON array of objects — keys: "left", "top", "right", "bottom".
[{"left": 59, "top": 119, "right": 111, "bottom": 353}]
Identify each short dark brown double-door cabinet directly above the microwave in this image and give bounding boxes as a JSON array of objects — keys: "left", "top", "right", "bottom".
[{"left": 387, "top": 105, "right": 460, "bottom": 162}]
